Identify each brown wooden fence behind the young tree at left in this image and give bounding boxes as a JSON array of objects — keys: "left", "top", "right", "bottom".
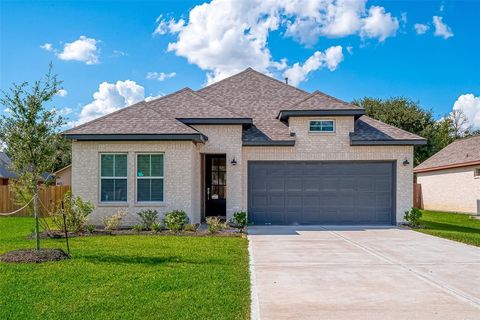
[{"left": 0, "top": 186, "right": 70, "bottom": 216}]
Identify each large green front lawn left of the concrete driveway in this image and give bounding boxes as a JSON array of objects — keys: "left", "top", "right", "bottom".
[{"left": 0, "top": 217, "right": 250, "bottom": 319}]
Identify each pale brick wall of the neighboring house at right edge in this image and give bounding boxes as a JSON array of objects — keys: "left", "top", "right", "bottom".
[{"left": 417, "top": 166, "right": 480, "bottom": 214}]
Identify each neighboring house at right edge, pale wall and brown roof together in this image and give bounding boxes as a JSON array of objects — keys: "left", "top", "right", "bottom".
[{"left": 414, "top": 136, "right": 480, "bottom": 215}]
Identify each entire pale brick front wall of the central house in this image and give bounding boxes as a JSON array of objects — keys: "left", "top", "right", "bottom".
[{"left": 72, "top": 117, "right": 413, "bottom": 224}]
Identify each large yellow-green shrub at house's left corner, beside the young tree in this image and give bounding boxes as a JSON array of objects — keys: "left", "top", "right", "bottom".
[{"left": 52, "top": 192, "right": 94, "bottom": 233}]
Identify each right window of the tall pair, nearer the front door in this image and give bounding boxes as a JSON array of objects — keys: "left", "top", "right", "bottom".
[{"left": 137, "top": 154, "right": 163, "bottom": 202}]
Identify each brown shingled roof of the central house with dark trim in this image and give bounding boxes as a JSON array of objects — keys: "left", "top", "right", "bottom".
[{"left": 65, "top": 68, "right": 424, "bottom": 145}]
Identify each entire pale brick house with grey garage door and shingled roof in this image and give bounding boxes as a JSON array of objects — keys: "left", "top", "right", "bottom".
[{"left": 65, "top": 68, "right": 426, "bottom": 224}]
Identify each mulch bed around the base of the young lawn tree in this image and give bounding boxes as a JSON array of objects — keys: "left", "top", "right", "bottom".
[{"left": 0, "top": 249, "right": 70, "bottom": 263}]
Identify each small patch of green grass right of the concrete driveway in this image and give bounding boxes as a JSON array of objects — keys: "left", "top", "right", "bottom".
[{"left": 415, "top": 210, "right": 480, "bottom": 247}]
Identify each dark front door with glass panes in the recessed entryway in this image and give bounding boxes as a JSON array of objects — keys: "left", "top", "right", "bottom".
[{"left": 205, "top": 154, "right": 227, "bottom": 217}]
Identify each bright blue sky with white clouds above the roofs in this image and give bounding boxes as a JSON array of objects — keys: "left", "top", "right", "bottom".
[{"left": 0, "top": 0, "right": 480, "bottom": 128}]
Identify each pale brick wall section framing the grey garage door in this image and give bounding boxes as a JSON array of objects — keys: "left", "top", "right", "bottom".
[{"left": 246, "top": 117, "right": 413, "bottom": 222}]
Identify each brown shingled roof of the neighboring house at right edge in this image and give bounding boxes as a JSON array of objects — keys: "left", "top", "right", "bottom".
[{"left": 414, "top": 136, "right": 480, "bottom": 172}]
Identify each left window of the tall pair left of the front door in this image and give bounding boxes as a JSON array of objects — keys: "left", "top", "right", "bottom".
[{"left": 100, "top": 154, "right": 127, "bottom": 202}]
